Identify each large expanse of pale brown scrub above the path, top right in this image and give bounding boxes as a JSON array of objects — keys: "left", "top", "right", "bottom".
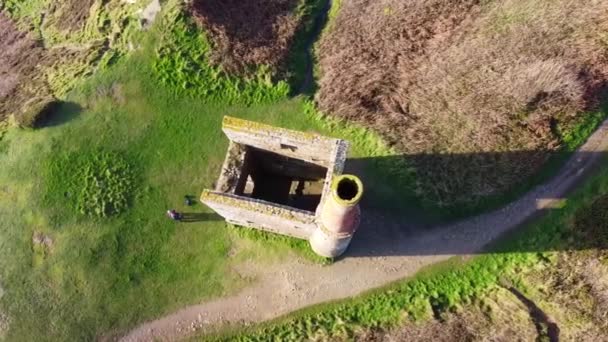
[{"left": 316, "top": 0, "right": 608, "bottom": 205}]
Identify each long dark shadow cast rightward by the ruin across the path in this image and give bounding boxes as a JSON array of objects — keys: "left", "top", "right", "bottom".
[{"left": 343, "top": 148, "right": 608, "bottom": 258}]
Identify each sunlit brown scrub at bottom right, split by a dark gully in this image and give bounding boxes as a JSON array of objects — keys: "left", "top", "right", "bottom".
[{"left": 356, "top": 250, "right": 608, "bottom": 342}]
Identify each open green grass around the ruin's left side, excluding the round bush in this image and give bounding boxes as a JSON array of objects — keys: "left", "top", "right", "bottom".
[{"left": 0, "top": 2, "right": 400, "bottom": 340}]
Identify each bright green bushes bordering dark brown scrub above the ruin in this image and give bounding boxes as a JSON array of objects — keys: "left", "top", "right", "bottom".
[{"left": 153, "top": 15, "right": 290, "bottom": 105}]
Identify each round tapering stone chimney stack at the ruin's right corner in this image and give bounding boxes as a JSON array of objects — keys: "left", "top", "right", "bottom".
[{"left": 310, "top": 175, "right": 363, "bottom": 258}]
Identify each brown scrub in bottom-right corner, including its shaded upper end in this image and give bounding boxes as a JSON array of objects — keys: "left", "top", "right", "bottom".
[{"left": 355, "top": 195, "right": 608, "bottom": 342}]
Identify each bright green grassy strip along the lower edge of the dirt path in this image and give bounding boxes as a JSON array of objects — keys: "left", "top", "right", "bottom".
[{"left": 210, "top": 160, "right": 608, "bottom": 341}]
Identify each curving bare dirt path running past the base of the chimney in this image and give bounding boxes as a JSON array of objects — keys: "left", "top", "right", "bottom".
[{"left": 117, "top": 120, "right": 608, "bottom": 341}]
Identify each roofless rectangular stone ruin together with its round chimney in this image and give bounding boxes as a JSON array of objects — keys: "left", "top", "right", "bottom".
[{"left": 201, "top": 116, "right": 363, "bottom": 257}]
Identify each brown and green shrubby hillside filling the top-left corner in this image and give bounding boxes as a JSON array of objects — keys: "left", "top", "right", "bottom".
[{"left": 0, "top": 0, "right": 143, "bottom": 127}]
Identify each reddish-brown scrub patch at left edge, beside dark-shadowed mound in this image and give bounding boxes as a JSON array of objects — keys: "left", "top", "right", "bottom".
[{"left": 0, "top": 14, "right": 53, "bottom": 125}]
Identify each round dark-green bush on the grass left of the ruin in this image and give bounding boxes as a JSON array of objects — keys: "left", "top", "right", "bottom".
[{"left": 46, "top": 151, "right": 135, "bottom": 217}]
